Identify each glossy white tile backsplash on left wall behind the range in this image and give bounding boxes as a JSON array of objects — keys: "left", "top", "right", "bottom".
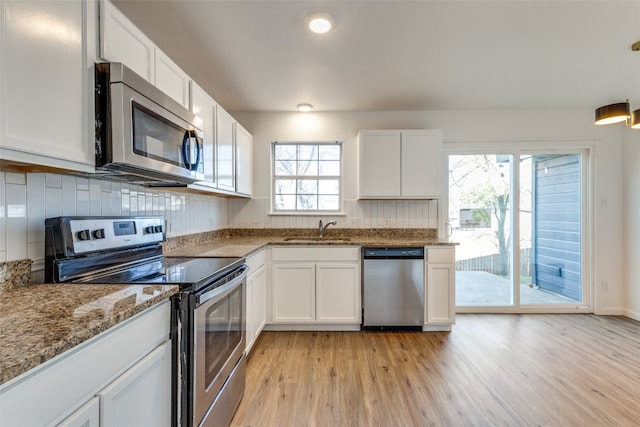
[{"left": 0, "top": 172, "right": 227, "bottom": 270}]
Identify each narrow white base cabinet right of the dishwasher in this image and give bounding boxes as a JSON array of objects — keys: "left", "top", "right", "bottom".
[{"left": 425, "top": 246, "right": 456, "bottom": 330}]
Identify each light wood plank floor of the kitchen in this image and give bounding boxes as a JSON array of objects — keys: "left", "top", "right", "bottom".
[{"left": 232, "top": 314, "right": 640, "bottom": 427}]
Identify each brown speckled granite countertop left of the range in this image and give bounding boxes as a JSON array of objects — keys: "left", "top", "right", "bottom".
[{"left": 0, "top": 284, "right": 178, "bottom": 384}]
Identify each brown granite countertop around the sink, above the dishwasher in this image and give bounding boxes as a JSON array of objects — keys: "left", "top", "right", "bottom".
[{"left": 164, "top": 228, "right": 456, "bottom": 257}]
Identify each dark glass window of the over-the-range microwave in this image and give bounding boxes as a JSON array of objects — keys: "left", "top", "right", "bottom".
[{"left": 132, "top": 102, "right": 186, "bottom": 167}]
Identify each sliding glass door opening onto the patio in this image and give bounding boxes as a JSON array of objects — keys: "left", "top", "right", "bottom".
[{"left": 448, "top": 151, "right": 588, "bottom": 311}]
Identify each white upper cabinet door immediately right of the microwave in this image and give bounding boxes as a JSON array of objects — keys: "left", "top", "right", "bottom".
[{"left": 190, "top": 81, "right": 216, "bottom": 187}]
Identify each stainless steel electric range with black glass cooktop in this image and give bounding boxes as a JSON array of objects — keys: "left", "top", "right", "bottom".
[{"left": 45, "top": 216, "right": 247, "bottom": 427}]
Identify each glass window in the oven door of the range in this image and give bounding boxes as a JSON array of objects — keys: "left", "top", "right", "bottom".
[{"left": 205, "top": 287, "right": 242, "bottom": 387}]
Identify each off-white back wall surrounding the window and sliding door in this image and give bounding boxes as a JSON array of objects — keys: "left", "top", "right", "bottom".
[{"left": 235, "top": 110, "right": 624, "bottom": 314}]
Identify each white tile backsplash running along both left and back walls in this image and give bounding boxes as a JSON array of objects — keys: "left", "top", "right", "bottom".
[{"left": 0, "top": 172, "right": 438, "bottom": 270}]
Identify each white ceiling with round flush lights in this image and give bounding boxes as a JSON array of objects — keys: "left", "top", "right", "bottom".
[{"left": 114, "top": 0, "right": 640, "bottom": 112}]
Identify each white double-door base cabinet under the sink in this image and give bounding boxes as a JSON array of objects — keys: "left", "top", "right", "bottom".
[{"left": 271, "top": 246, "right": 361, "bottom": 325}]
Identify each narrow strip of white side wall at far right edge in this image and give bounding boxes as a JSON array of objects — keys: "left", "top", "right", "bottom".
[{"left": 623, "top": 129, "right": 640, "bottom": 320}]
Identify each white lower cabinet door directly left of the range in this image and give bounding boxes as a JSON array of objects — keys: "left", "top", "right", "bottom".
[{"left": 98, "top": 341, "right": 171, "bottom": 427}]
